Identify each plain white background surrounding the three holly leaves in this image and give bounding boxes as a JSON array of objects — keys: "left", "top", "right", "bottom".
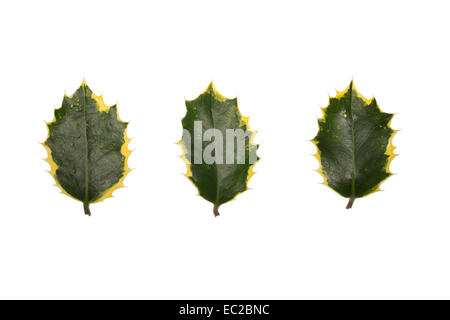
[{"left": 0, "top": 0, "right": 450, "bottom": 299}]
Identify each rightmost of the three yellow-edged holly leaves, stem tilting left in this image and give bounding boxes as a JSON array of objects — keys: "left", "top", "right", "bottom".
[{"left": 312, "top": 81, "right": 397, "bottom": 209}]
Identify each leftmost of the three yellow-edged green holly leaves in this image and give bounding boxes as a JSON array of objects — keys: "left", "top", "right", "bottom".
[{"left": 43, "top": 81, "right": 131, "bottom": 215}]
